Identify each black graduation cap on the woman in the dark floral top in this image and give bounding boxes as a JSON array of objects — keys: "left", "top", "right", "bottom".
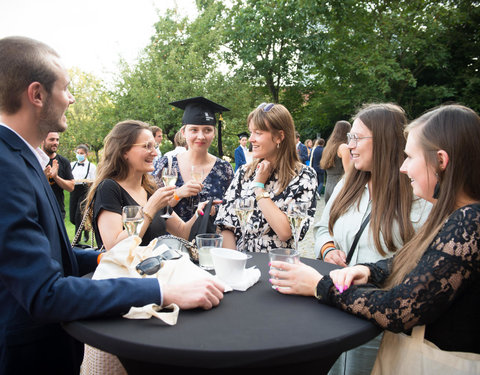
[{"left": 168, "top": 96, "right": 230, "bottom": 126}]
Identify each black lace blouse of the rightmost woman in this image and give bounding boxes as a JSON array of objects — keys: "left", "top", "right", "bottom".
[{"left": 318, "top": 204, "right": 480, "bottom": 353}]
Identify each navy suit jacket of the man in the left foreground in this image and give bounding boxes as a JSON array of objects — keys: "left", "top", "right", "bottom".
[{"left": 0, "top": 126, "right": 160, "bottom": 374}]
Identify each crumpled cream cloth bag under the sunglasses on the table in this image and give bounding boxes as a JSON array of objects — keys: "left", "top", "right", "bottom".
[{"left": 92, "top": 236, "right": 232, "bottom": 325}]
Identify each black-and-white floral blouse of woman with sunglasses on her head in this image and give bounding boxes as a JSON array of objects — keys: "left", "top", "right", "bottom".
[{"left": 215, "top": 165, "right": 317, "bottom": 252}]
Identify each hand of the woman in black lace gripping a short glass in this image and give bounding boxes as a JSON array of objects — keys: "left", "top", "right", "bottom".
[{"left": 269, "top": 261, "right": 323, "bottom": 296}]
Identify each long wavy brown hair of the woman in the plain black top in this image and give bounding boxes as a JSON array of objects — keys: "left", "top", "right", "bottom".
[{"left": 85, "top": 120, "right": 157, "bottom": 223}]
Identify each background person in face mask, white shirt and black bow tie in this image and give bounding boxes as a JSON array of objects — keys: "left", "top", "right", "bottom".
[{"left": 69, "top": 144, "right": 97, "bottom": 241}]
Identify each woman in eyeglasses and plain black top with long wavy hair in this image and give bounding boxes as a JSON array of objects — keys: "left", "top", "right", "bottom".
[{"left": 85, "top": 120, "right": 204, "bottom": 250}]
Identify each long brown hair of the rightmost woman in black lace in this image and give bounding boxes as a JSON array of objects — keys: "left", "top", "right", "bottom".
[{"left": 385, "top": 104, "right": 480, "bottom": 288}]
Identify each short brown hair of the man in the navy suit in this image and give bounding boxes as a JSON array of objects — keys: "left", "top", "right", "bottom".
[{"left": 0, "top": 36, "right": 60, "bottom": 114}]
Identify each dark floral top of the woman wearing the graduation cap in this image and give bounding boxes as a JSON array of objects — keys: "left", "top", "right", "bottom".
[{"left": 154, "top": 156, "right": 233, "bottom": 221}]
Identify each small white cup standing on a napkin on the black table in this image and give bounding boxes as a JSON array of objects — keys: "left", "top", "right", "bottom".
[{"left": 210, "top": 248, "right": 248, "bottom": 285}]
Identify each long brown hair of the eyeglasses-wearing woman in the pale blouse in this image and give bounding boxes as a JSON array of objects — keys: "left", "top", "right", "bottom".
[{"left": 328, "top": 103, "right": 415, "bottom": 256}]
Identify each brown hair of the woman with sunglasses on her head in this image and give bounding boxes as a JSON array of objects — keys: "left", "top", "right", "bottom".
[{"left": 246, "top": 104, "right": 302, "bottom": 194}]
